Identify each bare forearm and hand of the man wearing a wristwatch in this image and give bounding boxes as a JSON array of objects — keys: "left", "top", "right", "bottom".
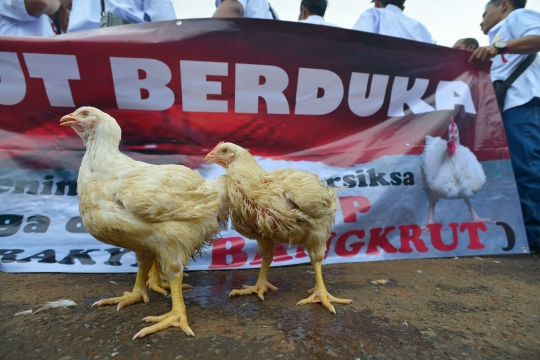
[{"left": 469, "top": 35, "right": 540, "bottom": 70}]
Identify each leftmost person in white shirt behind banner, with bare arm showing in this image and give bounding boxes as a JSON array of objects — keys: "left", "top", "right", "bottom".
[{"left": 0, "top": 0, "right": 67, "bottom": 36}]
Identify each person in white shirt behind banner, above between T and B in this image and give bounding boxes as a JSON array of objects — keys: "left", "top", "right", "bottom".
[{"left": 68, "top": 0, "right": 176, "bottom": 33}]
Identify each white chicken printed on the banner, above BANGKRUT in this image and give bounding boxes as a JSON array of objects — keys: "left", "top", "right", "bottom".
[{"left": 422, "top": 117, "right": 493, "bottom": 226}]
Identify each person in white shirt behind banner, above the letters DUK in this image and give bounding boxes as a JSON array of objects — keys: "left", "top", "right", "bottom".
[{"left": 353, "top": 0, "right": 435, "bottom": 44}]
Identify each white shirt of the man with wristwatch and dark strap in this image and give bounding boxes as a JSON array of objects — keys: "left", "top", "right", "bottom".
[{"left": 488, "top": 9, "right": 540, "bottom": 110}]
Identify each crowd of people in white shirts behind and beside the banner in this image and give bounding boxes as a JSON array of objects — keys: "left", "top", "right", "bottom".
[{"left": 0, "top": 0, "right": 540, "bottom": 250}]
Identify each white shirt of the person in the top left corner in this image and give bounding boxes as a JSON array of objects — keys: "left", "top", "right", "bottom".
[{"left": 0, "top": 0, "right": 56, "bottom": 36}]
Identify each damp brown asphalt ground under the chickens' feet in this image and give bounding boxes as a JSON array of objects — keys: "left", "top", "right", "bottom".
[{"left": 0, "top": 255, "right": 540, "bottom": 360}]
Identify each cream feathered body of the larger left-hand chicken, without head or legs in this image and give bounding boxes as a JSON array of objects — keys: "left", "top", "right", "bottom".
[{"left": 77, "top": 151, "right": 226, "bottom": 273}]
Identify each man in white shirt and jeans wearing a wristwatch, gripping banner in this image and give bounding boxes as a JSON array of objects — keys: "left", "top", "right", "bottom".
[{"left": 469, "top": 0, "right": 540, "bottom": 251}]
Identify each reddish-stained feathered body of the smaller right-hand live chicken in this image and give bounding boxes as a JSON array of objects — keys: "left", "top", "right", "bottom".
[{"left": 227, "top": 159, "right": 338, "bottom": 258}]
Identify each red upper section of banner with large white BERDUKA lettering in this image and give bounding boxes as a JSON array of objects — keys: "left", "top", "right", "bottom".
[{"left": 0, "top": 19, "right": 508, "bottom": 167}]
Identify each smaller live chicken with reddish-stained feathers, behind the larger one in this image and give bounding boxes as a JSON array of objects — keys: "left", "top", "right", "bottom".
[{"left": 206, "top": 143, "right": 352, "bottom": 314}]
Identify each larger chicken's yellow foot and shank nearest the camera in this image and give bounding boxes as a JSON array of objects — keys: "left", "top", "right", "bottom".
[{"left": 133, "top": 273, "right": 195, "bottom": 340}]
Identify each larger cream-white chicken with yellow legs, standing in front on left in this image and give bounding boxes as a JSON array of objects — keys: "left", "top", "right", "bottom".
[{"left": 60, "top": 107, "right": 229, "bottom": 339}]
